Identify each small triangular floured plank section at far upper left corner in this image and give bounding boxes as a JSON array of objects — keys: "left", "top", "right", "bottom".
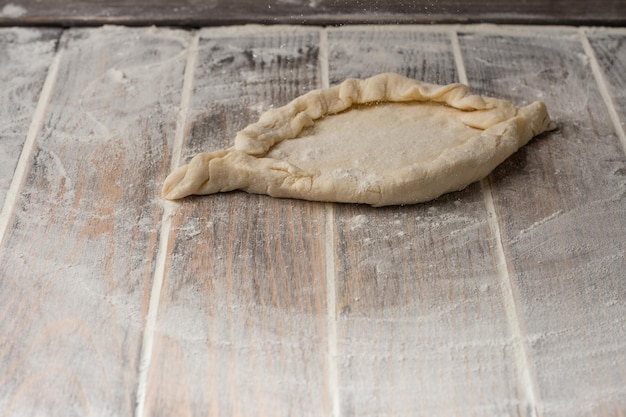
[{"left": 0, "top": 28, "right": 61, "bottom": 207}]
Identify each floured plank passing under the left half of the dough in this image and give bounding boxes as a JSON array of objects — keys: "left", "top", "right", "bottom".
[{"left": 145, "top": 27, "right": 329, "bottom": 416}]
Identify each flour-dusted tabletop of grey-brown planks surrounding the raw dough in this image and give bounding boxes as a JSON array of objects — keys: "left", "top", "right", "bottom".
[{"left": 0, "top": 25, "right": 626, "bottom": 417}]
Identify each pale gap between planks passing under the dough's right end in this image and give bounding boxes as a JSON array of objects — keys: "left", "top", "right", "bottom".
[{"left": 449, "top": 30, "right": 542, "bottom": 417}]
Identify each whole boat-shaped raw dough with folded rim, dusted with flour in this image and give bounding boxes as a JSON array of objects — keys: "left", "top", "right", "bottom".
[{"left": 163, "top": 74, "right": 555, "bottom": 206}]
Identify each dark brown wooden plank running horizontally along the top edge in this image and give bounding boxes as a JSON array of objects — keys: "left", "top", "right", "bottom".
[{"left": 0, "top": 0, "right": 626, "bottom": 27}]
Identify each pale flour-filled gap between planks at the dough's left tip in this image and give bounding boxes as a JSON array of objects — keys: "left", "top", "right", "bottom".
[{"left": 135, "top": 32, "right": 200, "bottom": 417}]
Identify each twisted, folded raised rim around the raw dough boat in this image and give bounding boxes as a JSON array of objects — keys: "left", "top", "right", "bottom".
[{"left": 163, "top": 73, "right": 554, "bottom": 206}]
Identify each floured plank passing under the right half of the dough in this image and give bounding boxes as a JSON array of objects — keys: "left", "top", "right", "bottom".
[{"left": 328, "top": 27, "right": 527, "bottom": 416}]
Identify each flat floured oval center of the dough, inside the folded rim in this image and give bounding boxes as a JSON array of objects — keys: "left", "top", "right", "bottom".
[{"left": 267, "top": 102, "right": 482, "bottom": 176}]
